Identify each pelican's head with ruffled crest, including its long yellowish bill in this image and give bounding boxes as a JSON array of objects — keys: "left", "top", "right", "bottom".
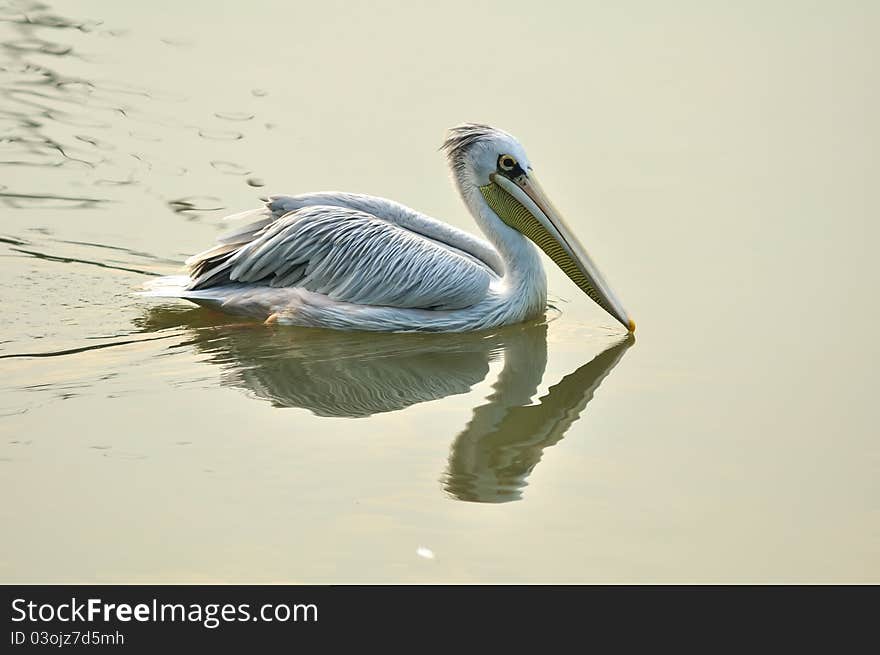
[{"left": 443, "top": 123, "right": 635, "bottom": 332}]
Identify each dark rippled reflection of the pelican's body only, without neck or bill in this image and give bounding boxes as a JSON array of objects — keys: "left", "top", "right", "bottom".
[{"left": 141, "top": 307, "right": 527, "bottom": 418}]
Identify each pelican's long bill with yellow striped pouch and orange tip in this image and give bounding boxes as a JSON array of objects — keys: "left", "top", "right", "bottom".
[{"left": 481, "top": 171, "right": 636, "bottom": 332}]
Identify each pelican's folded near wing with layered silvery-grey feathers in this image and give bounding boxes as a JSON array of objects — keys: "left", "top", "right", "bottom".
[{"left": 187, "top": 205, "right": 494, "bottom": 309}]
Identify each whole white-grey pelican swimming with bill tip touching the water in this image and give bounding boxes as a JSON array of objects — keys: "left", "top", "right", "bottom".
[{"left": 147, "top": 123, "right": 635, "bottom": 332}]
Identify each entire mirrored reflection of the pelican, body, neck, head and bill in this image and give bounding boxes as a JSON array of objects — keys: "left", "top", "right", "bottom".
[{"left": 139, "top": 307, "right": 634, "bottom": 502}]
